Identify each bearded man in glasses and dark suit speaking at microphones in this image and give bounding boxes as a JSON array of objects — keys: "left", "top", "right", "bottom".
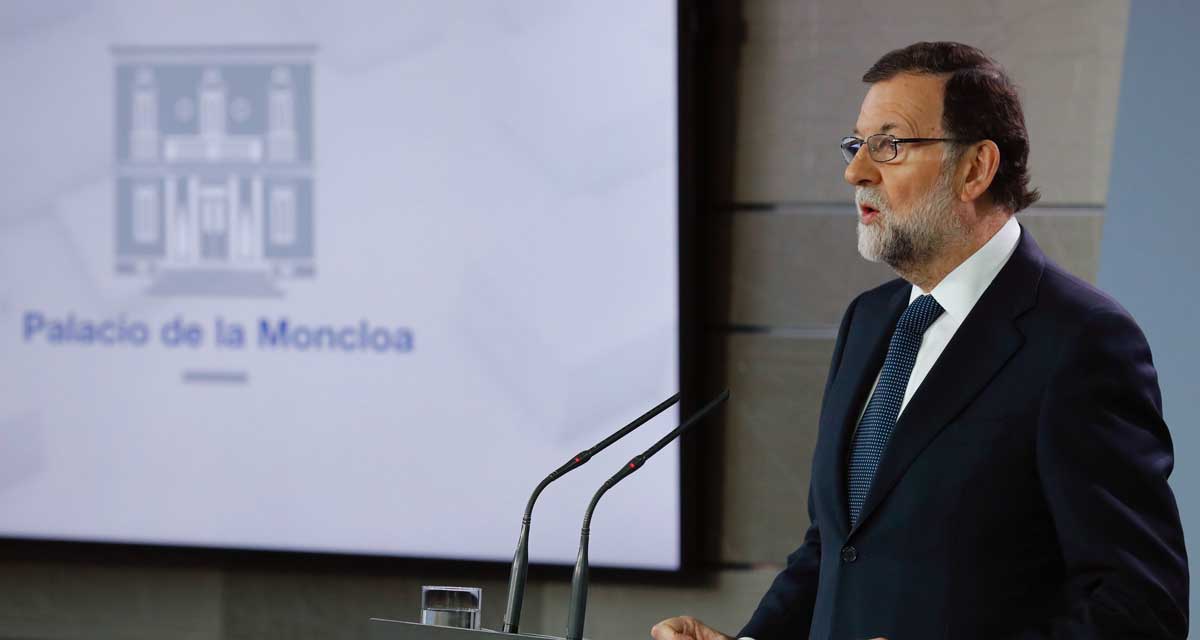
[{"left": 652, "top": 42, "right": 1188, "bottom": 640}]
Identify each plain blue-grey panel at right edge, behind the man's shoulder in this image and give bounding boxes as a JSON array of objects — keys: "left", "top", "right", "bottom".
[{"left": 1099, "top": 0, "right": 1200, "bottom": 616}]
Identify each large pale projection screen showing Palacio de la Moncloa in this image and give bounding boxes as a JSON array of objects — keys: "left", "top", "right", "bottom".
[{"left": 0, "top": 0, "right": 680, "bottom": 569}]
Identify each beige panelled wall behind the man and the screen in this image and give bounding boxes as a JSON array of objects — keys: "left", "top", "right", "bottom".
[{"left": 0, "top": 0, "right": 1128, "bottom": 640}]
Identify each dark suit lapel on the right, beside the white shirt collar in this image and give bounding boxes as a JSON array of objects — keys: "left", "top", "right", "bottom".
[{"left": 841, "top": 227, "right": 1044, "bottom": 534}]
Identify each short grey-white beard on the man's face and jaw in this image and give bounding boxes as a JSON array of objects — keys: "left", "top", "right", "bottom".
[{"left": 854, "top": 167, "right": 968, "bottom": 275}]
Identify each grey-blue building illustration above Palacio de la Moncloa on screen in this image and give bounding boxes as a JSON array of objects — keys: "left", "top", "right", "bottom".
[{"left": 113, "top": 47, "right": 316, "bottom": 297}]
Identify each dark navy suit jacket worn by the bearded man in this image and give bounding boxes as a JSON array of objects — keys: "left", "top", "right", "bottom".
[{"left": 739, "top": 228, "right": 1194, "bottom": 640}]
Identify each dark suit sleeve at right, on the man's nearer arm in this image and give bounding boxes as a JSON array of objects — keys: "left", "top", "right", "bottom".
[{"left": 1016, "top": 309, "right": 1188, "bottom": 640}]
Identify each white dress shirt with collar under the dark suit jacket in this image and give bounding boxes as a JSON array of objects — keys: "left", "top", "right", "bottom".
[{"left": 858, "top": 216, "right": 1021, "bottom": 420}]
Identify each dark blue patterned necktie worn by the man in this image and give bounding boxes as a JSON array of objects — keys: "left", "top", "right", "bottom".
[{"left": 847, "top": 294, "right": 942, "bottom": 526}]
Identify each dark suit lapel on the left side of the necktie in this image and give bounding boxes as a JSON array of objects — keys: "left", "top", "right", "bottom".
[{"left": 826, "top": 286, "right": 911, "bottom": 537}]
